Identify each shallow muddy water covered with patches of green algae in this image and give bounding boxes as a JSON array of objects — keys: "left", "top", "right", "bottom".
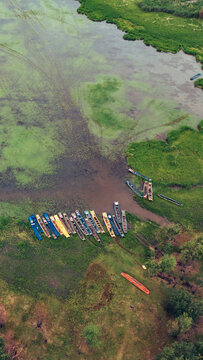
[{"left": 0, "top": 0, "right": 203, "bottom": 222}]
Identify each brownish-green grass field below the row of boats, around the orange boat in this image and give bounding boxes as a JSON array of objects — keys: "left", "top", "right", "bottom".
[{"left": 0, "top": 217, "right": 170, "bottom": 360}]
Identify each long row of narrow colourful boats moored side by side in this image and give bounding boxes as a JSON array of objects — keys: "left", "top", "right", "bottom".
[{"left": 28, "top": 202, "right": 127, "bottom": 242}]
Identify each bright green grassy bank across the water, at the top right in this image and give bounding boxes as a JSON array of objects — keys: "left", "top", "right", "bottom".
[{"left": 78, "top": 0, "right": 203, "bottom": 67}]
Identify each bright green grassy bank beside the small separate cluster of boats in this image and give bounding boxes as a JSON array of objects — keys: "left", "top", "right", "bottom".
[{"left": 126, "top": 122, "right": 203, "bottom": 228}]
